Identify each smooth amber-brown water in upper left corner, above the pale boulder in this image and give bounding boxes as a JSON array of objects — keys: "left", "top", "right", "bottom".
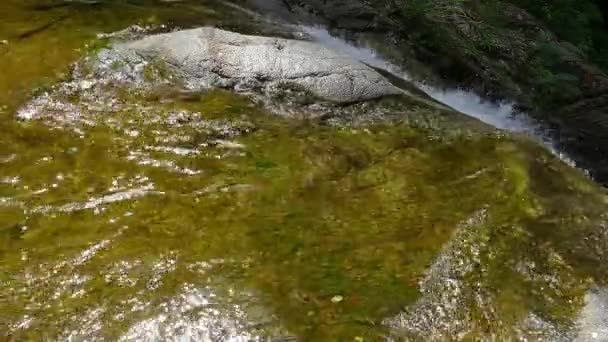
[{"left": 0, "top": 0, "right": 264, "bottom": 113}]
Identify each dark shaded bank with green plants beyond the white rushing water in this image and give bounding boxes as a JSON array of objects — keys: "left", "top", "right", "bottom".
[{"left": 393, "top": 0, "right": 608, "bottom": 183}]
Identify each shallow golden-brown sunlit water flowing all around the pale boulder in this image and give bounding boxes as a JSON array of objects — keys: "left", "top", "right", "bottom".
[{"left": 0, "top": 0, "right": 608, "bottom": 341}]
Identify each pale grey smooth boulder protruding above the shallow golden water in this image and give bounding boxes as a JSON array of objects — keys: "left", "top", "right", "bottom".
[{"left": 106, "top": 28, "right": 403, "bottom": 103}]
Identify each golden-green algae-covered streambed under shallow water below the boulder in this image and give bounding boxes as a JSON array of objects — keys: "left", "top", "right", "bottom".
[{"left": 0, "top": 86, "right": 605, "bottom": 340}]
